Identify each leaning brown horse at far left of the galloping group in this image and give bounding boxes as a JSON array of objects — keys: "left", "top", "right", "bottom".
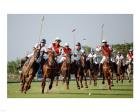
[{"left": 20, "top": 50, "right": 40, "bottom": 94}]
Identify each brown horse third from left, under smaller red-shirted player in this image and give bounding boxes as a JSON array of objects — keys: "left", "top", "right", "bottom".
[{"left": 60, "top": 55, "right": 71, "bottom": 89}]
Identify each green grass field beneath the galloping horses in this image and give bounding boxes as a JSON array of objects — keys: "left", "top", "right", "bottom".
[{"left": 7, "top": 80, "right": 133, "bottom": 98}]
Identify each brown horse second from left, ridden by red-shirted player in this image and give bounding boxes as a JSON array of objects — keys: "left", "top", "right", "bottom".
[{"left": 41, "top": 51, "right": 57, "bottom": 94}]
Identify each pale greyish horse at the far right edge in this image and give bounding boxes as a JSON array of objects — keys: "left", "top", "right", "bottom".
[{"left": 126, "top": 62, "right": 133, "bottom": 83}]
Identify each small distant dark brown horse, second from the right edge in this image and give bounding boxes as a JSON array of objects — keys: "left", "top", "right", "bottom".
[{"left": 116, "top": 59, "right": 125, "bottom": 83}]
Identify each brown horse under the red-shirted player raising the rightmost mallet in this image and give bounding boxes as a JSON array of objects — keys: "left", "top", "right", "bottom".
[{"left": 102, "top": 58, "right": 112, "bottom": 90}]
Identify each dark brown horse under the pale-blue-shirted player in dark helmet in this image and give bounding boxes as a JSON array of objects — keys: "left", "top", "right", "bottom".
[{"left": 75, "top": 54, "right": 88, "bottom": 89}]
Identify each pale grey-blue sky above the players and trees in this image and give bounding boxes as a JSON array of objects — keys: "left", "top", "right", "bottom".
[{"left": 7, "top": 14, "right": 133, "bottom": 61}]
